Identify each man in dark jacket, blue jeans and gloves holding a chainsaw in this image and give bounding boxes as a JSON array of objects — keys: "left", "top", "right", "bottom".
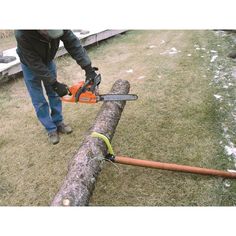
[{"left": 15, "top": 30, "right": 97, "bottom": 144}]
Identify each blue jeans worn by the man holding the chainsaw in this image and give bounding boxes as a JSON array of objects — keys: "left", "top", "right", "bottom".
[{"left": 21, "top": 62, "right": 63, "bottom": 133}]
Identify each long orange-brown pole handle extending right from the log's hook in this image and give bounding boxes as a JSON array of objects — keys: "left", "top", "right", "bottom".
[{"left": 114, "top": 156, "right": 236, "bottom": 179}]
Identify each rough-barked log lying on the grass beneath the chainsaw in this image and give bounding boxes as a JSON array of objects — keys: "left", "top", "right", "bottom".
[{"left": 51, "top": 80, "right": 130, "bottom": 206}]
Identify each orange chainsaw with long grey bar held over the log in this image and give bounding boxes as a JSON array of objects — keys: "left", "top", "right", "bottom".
[{"left": 61, "top": 74, "right": 138, "bottom": 104}]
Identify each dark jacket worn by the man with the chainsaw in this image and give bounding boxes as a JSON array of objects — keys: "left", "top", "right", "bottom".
[{"left": 15, "top": 30, "right": 91, "bottom": 83}]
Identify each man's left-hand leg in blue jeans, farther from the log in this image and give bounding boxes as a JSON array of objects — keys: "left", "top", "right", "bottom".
[{"left": 21, "top": 64, "right": 57, "bottom": 143}]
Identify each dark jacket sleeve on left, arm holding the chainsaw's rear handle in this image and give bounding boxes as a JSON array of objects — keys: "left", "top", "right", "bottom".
[{"left": 15, "top": 32, "right": 56, "bottom": 84}]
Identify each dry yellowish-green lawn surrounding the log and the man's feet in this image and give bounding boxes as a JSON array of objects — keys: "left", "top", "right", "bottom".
[{"left": 0, "top": 31, "right": 236, "bottom": 206}]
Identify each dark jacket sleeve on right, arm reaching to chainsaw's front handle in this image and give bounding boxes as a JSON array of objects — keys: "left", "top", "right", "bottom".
[{"left": 60, "top": 30, "right": 91, "bottom": 69}]
